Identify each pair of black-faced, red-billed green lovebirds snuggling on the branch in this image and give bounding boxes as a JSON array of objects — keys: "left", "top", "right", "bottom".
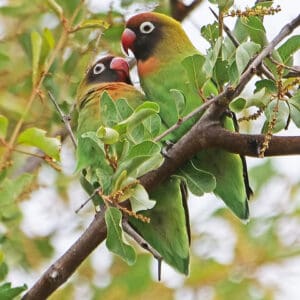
[{"left": 76, "top": 12, "right": 251, "bottom": 274}]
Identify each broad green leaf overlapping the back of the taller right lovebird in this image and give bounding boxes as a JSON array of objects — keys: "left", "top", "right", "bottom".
[{"left": 182, "top": 54, "right": 207, "bottom": 90}]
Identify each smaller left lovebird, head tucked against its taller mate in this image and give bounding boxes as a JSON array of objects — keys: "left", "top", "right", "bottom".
[{"left": 76, "top": 56, "right": 190, "bottom": 274}]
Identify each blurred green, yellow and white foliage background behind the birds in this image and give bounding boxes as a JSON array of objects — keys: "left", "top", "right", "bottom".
[{"left": 0, "top": 0, "right": 300, "bottom": 299}]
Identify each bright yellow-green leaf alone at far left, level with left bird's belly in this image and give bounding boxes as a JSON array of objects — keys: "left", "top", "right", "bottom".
[{"left": 18, "top": 127, "right": 61, "bottom": 161}]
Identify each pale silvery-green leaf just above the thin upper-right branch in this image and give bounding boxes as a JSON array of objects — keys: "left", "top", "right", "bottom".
[{"left": 235, "top": 42, "right": 260, "bottom": 75}]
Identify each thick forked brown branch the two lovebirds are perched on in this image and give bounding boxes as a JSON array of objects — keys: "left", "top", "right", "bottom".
[{"left": 22, "top": 11, "right": 300, "bottom": 300}]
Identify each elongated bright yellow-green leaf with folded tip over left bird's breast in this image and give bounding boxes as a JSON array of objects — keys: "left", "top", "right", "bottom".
[{"left": 113, "top": 101, "right": 159, "bottom": 134}]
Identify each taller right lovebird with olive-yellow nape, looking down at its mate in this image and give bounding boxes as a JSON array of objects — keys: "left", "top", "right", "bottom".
[{"left": 122, "top": 12, "right": 251, "bottom": 219}]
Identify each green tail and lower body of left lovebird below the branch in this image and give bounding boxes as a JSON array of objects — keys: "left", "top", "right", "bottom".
[{"left": 130, "top": 177, "right": 190, "bottom": 274}]
